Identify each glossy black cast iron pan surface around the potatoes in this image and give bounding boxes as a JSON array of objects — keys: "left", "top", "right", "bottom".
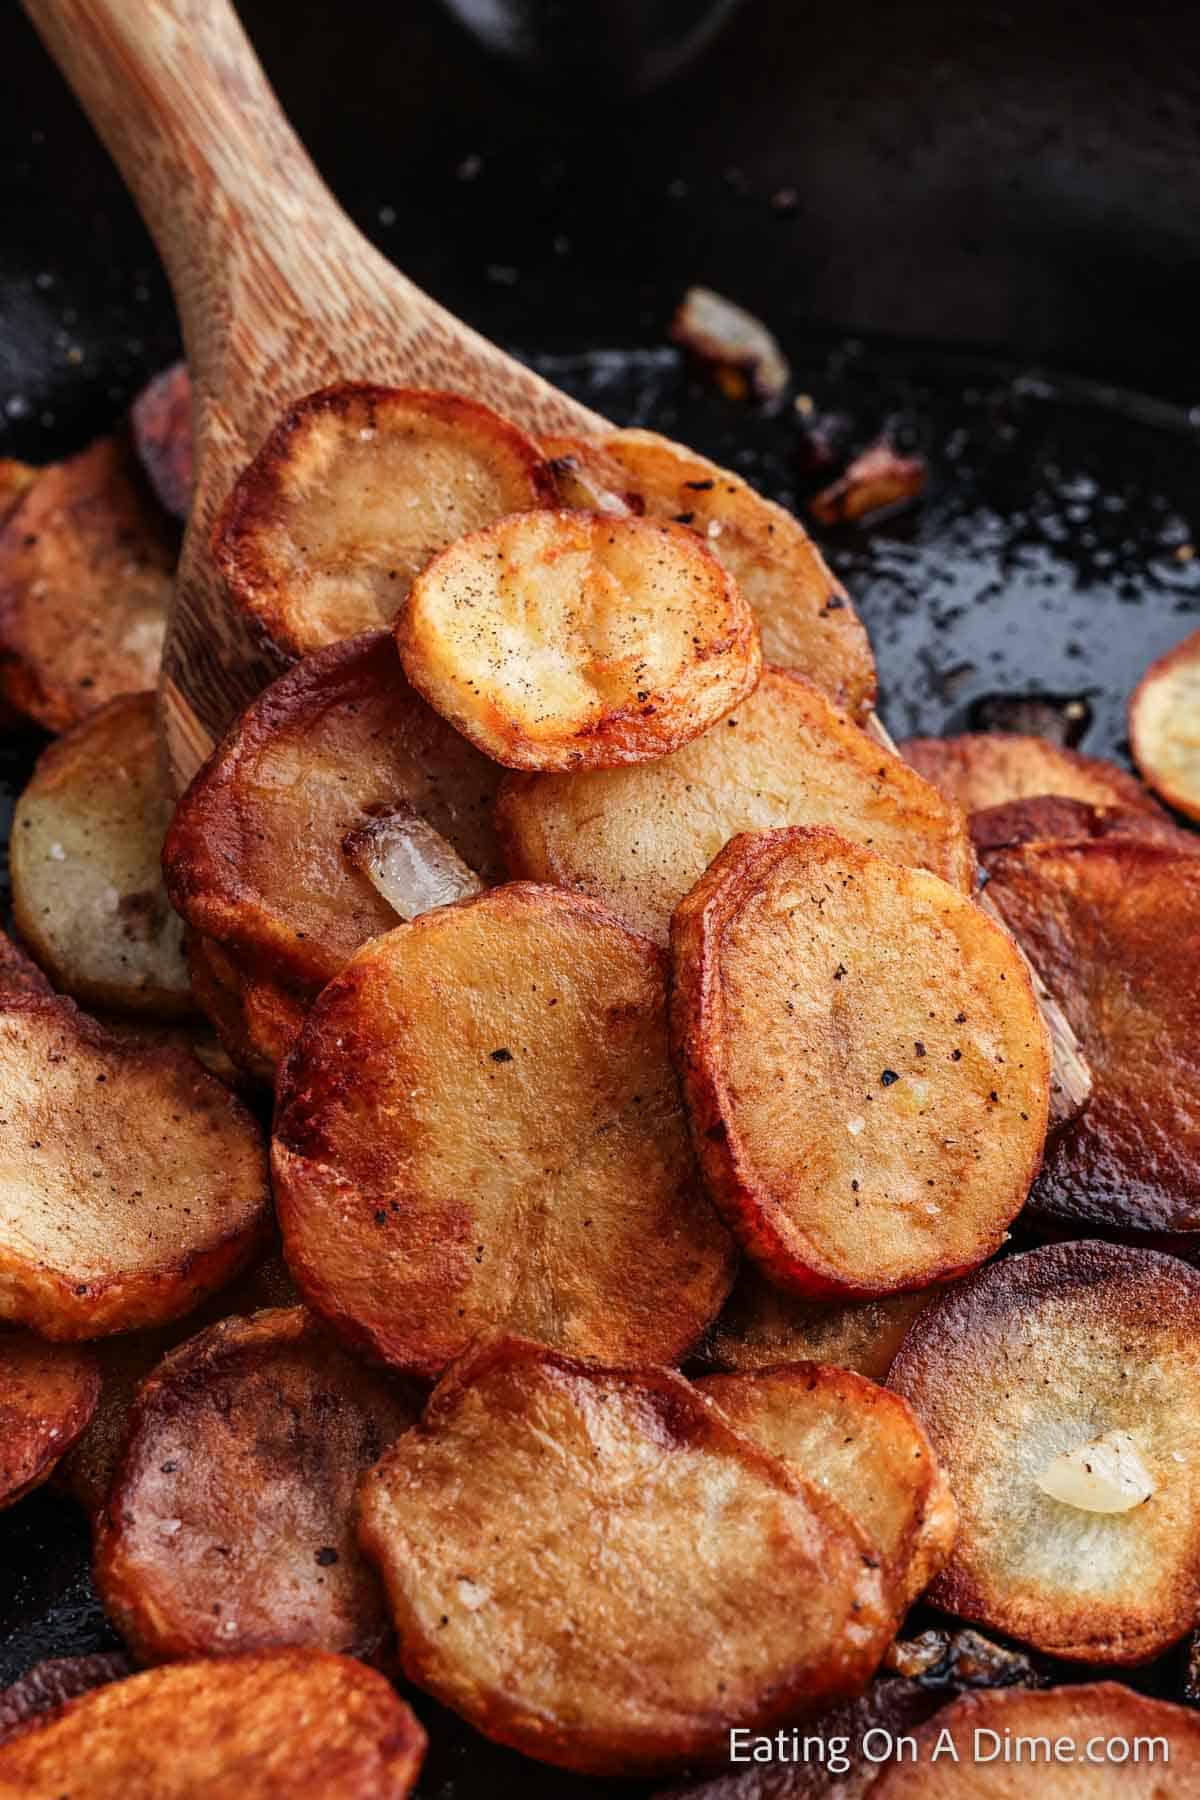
[{"left": 0, "top": 0, "right": 1200, "bottom": 1800}]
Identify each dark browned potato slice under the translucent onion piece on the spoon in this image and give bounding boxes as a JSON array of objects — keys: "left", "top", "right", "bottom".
[{"left": 164, "top": 632, "right": 500, "bottom": 1075}]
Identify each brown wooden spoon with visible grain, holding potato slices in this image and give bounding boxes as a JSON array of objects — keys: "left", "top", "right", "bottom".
[{"left": 23, "top": 0, "right": 606, "bottom": 785}]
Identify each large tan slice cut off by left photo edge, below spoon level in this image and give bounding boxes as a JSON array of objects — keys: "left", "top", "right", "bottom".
[{"left": 0, "top": 997, "right": 270, "bottom": 1339}]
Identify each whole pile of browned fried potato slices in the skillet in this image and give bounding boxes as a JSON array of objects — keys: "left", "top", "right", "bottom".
[{"left": 0, "top": 369, "right": 1200, "bottom": 1800}]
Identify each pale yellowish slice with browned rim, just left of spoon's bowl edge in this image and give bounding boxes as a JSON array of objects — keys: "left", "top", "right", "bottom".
[{"left": 9, "top": 693, "right": 194, "bottom": 1019}]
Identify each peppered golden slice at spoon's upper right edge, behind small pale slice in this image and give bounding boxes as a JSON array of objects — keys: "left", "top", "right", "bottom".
[{"left": 603, "top": 430, "right": 874, "bottom": 718}]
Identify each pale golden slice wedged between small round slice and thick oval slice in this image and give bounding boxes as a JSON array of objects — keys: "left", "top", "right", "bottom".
[{"left": 497, "top": 670, "right": 975, "bottom": 943}]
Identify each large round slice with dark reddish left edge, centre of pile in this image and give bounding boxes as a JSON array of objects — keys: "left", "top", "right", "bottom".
[{"left": 273, "top": 886, "right": 734, "bottom": 1375}]
